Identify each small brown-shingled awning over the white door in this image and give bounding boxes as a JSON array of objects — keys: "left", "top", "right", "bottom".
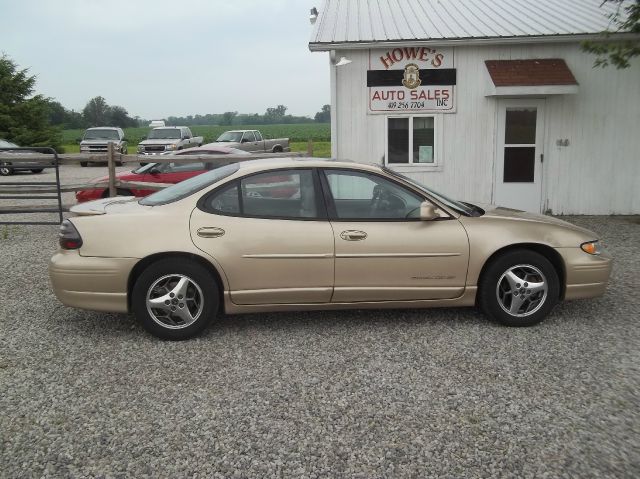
[{"left": 485, "top": 58, "right": 578, "bottom": 96}]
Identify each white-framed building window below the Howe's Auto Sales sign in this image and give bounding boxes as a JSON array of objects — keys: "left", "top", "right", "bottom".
[{"left": 387, "top": 116, "right": 438, "bottom": 167}]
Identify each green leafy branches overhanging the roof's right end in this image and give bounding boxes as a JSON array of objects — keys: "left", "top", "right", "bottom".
[{"left": 582, "top": 0, "right": 640, "bottom": 69}]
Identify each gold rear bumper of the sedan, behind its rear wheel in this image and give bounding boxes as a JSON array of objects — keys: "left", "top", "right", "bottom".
[{"left": 49, "top": 250, "right": 138, "bottom": 313}]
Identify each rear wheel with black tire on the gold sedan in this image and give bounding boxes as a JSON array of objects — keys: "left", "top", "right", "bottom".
[{"left": 131, "top": 258, "right": 220, "bottom": 341}]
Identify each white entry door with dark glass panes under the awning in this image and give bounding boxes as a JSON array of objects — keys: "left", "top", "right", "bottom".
[{"left": 493, "top": 100, "right": 544, "bottom": 213}]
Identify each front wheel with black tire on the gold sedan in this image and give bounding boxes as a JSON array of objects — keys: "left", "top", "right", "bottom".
[{"left": 478, "top": 249, "right": 560, "bottom": 326}]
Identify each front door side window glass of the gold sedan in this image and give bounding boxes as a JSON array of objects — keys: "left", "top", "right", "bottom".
[{"left": 325, "top": 170, "right": 424, "bottom": 220}]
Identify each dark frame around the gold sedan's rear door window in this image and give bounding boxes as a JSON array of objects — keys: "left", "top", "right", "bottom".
[{"left": 196, "top": 167, "right": 329, "bottom": 221}]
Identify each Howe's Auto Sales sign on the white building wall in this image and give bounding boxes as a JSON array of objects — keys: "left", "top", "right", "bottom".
[{"left": 367, "top": 47, "right": 456, "bottom": 113}]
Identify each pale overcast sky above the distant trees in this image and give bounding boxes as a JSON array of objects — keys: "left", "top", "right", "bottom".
[{"left": 0, "top": 0, "right": 330, "bottom": 119}]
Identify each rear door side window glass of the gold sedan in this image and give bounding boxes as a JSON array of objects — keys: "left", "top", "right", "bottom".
[{"left": 203, "top": 169, "right": 319, "bottom": 219}]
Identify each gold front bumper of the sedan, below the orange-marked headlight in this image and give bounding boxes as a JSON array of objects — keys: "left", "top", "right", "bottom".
[{"left": 558, "top": 248, "right": 613, "bottom": 299}]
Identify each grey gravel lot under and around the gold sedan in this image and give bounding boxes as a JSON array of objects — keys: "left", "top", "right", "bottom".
[{"left": 0, "top": 167, "right": 640, "bottom": 478}]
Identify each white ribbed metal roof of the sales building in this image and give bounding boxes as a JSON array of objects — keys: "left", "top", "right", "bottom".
[{"left": 311, "top": 0, "right": 631, "bottom": 48}]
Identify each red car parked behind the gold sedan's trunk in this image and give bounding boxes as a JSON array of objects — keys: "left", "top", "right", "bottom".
[{"left": 76, "top": 145, "right": 251, "bottom": 203}]
